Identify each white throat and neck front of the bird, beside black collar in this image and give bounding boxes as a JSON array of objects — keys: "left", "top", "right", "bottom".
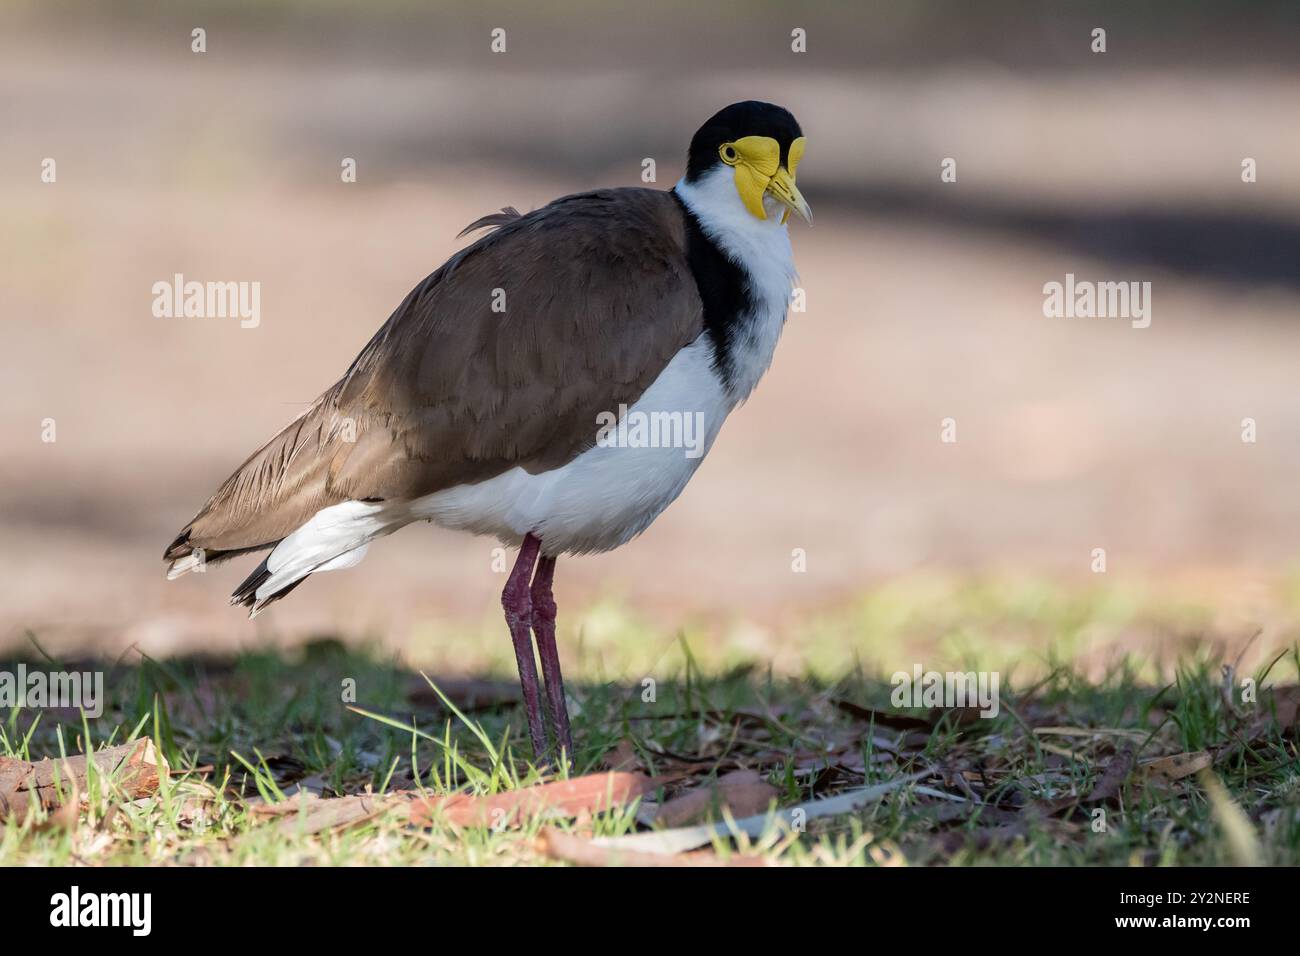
[{"left": 676, "top": 165, "right": 798, "bottom": 402}]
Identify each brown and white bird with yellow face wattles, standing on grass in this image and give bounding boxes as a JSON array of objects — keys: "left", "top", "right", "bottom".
[{"left": 164, "top": 100, "right": 813, "bottom": 761}]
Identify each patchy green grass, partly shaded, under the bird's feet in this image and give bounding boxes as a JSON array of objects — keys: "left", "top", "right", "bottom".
[{"left": 0, "top": 574, "right": 1300, "bottom": 866}]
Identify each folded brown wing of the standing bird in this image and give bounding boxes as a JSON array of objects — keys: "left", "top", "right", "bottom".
[{"left": 165, "top": 189, "right": 703, "bottom": 559}]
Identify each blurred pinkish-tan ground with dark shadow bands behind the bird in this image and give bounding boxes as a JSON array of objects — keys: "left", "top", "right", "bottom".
[{"left": 0, "top": 0, "right": 1300, "bottom": 654}]
